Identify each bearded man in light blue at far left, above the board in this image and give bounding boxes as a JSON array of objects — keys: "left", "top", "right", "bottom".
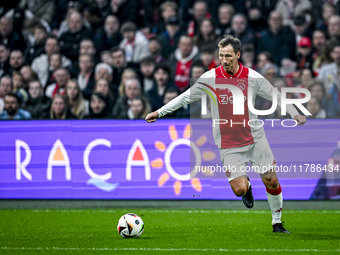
[{"left": 0, "top": 92, "right": 31, "bottom": 120}]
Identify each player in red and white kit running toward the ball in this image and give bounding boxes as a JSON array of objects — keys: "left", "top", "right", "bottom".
[{"left": 145, "top": 35, "right": 306, "bottom": 233}]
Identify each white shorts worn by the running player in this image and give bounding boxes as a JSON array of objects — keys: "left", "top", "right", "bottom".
[{"left": 220, "top": 136, "right": 276, "bottom": 182}]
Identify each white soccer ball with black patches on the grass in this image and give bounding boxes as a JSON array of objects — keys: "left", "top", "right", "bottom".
[{"left": 117, "top": 213, "right": 144, "bottom": 238}]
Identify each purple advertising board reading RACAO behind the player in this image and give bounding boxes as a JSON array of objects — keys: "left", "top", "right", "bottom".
[{"left": 0, "top": 120, "right": 340, "bottom": 200}]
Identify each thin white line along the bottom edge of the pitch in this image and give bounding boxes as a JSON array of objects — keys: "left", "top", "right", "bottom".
[{"left": 0, "top": 247, "right": 340, "bottom": 252}]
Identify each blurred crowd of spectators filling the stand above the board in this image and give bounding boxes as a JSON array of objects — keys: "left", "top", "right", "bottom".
[{"left": 0, "top": 0, "right": 340, "bottom": 119}]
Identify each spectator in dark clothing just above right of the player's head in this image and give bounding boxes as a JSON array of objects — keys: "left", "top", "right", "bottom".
[{"left": 228, "top": 13, "right": 256, "bottom": 45}]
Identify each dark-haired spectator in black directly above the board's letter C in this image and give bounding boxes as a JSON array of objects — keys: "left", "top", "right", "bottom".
[{"left": 85, "top": 92, "right": 111, "bottom": 119}]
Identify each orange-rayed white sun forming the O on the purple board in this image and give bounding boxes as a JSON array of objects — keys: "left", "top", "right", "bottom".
[{"left": 151, "top": 124, "right": 216, "bottom": 195}]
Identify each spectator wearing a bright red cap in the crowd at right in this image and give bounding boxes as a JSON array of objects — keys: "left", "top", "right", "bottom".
[{"left": 296, "top": 36, "right": 313, "bottom": 69}]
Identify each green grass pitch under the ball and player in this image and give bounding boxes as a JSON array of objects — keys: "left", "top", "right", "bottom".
[{"left": 0, "top": 208, "right": 340, "bottom": 255}]
